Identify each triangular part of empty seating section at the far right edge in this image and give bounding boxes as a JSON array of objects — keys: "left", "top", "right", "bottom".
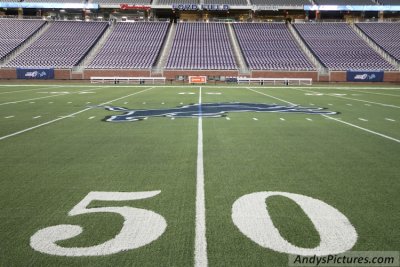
[{"left": 357, "top": 22, "right": 400, "bottom": 61}]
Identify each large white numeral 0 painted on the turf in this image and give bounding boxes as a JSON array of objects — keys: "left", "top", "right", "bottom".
[{"left": 232, "top": 192, "right": 357, "bottom": 256}]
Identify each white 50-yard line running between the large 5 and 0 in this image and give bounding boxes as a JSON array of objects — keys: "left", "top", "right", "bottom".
[{"left": 194, "top": 87, "right": 208, "bottom": 267}]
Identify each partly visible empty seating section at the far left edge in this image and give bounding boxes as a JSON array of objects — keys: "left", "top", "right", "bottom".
[{"left": 0, "top": 19, "right": 45, "bottom": 59}]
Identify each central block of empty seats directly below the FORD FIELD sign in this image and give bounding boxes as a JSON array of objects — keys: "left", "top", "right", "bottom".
[{"left": 166, "top": 23, "right": 237, "bottom": 69}]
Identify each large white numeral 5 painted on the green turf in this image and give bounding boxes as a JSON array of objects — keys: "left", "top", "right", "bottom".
[{"left": 30, "top": 191, "right": 167, "bottom": 256}]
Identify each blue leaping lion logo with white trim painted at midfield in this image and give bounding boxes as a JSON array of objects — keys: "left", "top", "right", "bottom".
[{"left": 100, "top": 102, "right": 338, "bottom": 122}]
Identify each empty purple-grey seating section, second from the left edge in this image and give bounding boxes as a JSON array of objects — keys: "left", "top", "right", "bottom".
[{"left": 7, "top": 21, "right": 108, "bottom": 68}]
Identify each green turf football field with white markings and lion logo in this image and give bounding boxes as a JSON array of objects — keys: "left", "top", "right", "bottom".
[{"left": 0, "top": 84, "right": 400, "bottom": 267}]
